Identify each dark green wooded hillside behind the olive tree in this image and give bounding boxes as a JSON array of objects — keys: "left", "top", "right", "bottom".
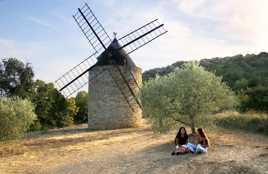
[{"left": 143, "top": 52, "right": 268, "bottom": 111}]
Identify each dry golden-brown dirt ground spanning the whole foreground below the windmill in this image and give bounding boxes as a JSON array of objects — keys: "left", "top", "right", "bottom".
[{"left": 0, "top": 125, "right": 268, "bottom": 174}]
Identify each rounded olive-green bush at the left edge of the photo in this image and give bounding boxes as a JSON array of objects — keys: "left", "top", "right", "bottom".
[{"left": 0, "top": 97, "right": 36, "bottom": 140}]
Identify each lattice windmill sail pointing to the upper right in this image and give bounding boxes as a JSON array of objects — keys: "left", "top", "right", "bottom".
[{"left": 118, "top": 19, "right": 167, "bottom": 54}]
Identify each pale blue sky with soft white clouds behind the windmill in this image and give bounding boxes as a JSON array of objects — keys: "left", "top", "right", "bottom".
[{"left": 0, "top": 0, "right": 268, "bottom": 82}]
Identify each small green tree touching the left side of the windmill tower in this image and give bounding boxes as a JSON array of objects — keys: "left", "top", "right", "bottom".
[{"left": 74, "top": 91, "right": 88, "bottom": 124}]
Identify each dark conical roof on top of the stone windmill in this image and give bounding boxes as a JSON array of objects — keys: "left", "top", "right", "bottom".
[{"left": 95, "top": 38, "right": 136, "bottom": 67}]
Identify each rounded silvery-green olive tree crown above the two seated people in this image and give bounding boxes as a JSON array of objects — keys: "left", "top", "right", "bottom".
[{"left": 141, "top": 62, "right": 235, "bottom": 133}]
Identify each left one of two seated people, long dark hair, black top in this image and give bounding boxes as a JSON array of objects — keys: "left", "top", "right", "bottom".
[{"left": 171, "top": 127, "right": 189, "bottom": 155}]
